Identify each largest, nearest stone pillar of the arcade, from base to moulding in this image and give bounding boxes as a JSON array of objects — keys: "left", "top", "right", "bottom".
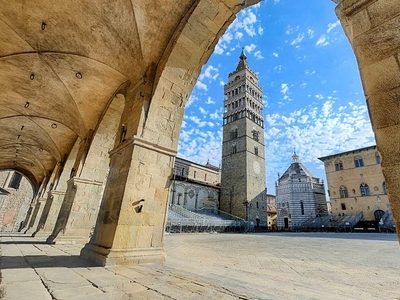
[{"left": 81, "top": 136, "right": 176, "bottom": 265}]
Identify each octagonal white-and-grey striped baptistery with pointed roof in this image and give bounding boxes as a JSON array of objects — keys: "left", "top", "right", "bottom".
[{"left": 275, "top": 152, "right": 328, "bottom": 230}]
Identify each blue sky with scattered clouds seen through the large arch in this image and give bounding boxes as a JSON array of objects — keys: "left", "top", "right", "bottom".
[{"left": 178, "top": 0, "right": 375, "bottom": 194}]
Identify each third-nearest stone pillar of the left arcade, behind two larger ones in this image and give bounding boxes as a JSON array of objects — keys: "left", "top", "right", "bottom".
[{"left": 35, "top": 191, "right": 65, "bottom": 237}]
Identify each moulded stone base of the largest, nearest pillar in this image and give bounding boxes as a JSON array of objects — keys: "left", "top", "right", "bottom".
[{"left": 80, "top": 243, "right": 166, "bottom": 267}]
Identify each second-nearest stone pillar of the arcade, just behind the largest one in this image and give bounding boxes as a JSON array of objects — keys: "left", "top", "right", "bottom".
[{"left": 46, "top": 177, "right": 103, "bottom": 243}]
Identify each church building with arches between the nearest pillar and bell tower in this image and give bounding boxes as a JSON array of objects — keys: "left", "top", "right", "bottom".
[{"left": 170, "top": 157, "right": 221, "bottom": 210}]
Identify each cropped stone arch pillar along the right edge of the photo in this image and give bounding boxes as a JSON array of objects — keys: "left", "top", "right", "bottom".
[{"left": 335, "top": 0, "right": 400, "bottom": 238}]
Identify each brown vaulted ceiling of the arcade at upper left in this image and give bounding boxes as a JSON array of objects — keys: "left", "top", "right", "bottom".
[{"left": 0, "top": 0, "right": 196, "bottom": 188}]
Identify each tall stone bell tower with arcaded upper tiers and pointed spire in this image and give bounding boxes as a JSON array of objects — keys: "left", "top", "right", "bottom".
[{"left": 220, "top": 50, "right": 267, "bottom": 225}]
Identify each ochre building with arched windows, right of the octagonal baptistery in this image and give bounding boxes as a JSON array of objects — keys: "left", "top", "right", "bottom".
[{"left": 319, "top": 146, "right": 390, "bottom": 223}]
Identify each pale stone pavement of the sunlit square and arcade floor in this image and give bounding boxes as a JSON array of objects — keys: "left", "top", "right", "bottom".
[{"left": 0, "top": 233, "right": 400, "bottom": 300}]
